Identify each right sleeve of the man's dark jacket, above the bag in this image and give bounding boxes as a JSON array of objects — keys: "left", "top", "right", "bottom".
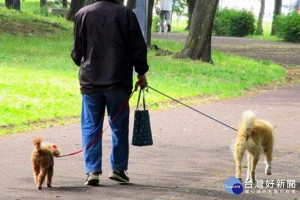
[{"left": 128, "top": 10, "right": 149, "bottom": 75}]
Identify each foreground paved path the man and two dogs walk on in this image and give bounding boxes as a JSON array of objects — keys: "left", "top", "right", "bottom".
[{"left": 0, "top": 85, "right": 300, "bottom": 200}]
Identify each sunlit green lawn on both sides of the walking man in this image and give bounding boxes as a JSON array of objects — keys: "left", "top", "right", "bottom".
[{"left": 0, "top": 6, "right": 286, "bottom": 134}]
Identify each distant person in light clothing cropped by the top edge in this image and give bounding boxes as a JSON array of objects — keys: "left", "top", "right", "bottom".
[{"left": 156, "top": 0, "right": 173, "bottom": 33}]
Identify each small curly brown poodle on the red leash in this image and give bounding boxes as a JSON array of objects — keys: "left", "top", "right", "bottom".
[{"left": 31, "top": 137, "right": 60, "bottom": 190}]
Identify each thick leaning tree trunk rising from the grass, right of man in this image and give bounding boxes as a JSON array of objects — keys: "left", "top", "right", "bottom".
[{"left": 175, "top": 0, "right": 219, "bottom": 63}]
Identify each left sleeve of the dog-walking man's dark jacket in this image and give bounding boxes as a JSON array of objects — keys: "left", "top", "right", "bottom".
[{"left": 71, "top": 16, "right": 83, "bottom": 66}]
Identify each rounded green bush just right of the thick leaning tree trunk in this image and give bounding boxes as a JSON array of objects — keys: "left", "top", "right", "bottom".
[{"left": 214, "top": 8, "right": 255, "bottom": 37}]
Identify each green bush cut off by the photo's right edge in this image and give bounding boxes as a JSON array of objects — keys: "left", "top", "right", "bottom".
[{"left": 274, "top": 12, "right": 300, "bottom": 42}]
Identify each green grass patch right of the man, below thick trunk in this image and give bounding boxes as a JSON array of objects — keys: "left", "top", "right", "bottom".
[{"left": 149, "top": 40, "right": 285, "bottom": 98}]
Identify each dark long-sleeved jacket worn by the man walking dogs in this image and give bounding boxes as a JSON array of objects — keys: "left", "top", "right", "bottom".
[{"left": 71, "top": 0, "right": 149, "bottom": 94}]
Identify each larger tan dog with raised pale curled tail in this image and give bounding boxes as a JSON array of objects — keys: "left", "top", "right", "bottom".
[{"left": 234, "top": 111, "right": 274, "bottom": 183}]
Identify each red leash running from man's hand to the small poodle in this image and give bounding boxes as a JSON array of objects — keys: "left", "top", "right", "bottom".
[{"left": 58, "top": 89, "right": 139, "bottom": 157}]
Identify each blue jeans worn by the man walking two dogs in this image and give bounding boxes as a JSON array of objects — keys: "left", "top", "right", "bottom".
[{"left": 81, "top": 90, "right": 129, "bottom": 174}]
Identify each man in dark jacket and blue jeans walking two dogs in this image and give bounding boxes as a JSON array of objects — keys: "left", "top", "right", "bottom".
[{"left": 71, "top": 0, "right": 149, "bottom": 185}]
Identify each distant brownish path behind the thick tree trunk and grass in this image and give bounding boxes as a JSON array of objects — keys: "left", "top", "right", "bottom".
[{"left": 152, "top": 33, "right": 300, "bottom": 66}]
